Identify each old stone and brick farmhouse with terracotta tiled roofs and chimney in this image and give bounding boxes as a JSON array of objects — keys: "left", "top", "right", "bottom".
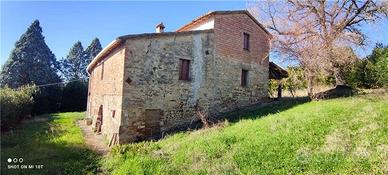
[{"left": 87, "top": 10, "right": 286, "bottom": 144}]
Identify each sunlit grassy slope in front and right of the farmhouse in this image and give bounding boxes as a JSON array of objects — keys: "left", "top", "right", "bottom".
[{"left": 103, "top": 95, "right": 388, "bottom": 174}]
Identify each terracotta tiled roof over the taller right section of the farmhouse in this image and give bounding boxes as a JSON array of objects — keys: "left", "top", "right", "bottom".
[{"left": 177, "top": 10, "right": 272, "bottom": 36}]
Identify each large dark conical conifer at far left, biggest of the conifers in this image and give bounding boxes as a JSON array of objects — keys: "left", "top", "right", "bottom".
[{"left": 0, "top": 20, "right": 61, "bottom": 88}]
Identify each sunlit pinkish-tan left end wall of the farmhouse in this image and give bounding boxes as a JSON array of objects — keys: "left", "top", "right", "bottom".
[{"left": 87, "top": 47, "right": 125, "bottom": 139}]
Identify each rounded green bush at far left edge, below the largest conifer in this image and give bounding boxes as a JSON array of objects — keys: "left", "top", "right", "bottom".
[{"left": 0, "top": 86, "right": 38, "bottom": 131}]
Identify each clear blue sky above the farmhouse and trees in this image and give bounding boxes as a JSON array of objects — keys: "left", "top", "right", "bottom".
[{"left": 0, "top": 1, "right": 388, "bottom": 66}]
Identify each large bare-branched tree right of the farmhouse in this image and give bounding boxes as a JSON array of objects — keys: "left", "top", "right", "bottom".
[{"left": 248, "top": 0, "right": 388, "bottom": 95}]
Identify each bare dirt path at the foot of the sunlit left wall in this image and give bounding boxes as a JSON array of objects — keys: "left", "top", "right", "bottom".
[{"left": 77, "top": 120, "right": 110, "bottom": 154}]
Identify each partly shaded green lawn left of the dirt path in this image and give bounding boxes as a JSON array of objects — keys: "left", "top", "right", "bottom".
[{"left": 1, "top": 112, "right": 99, "bottom": 174}]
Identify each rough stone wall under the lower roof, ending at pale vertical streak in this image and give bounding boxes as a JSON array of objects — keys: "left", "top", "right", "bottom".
[{"left": 120, "top": 32, "right": 214, "bottom": 143}]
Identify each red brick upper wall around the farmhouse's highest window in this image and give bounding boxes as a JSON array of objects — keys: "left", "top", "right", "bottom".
[{"left": 214, "top": 14, "right": 270, "bottom": 67}]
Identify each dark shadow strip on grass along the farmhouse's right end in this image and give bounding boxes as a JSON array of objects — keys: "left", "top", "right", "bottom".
[{"left": 226, "top": 97, "right": 311, "bottom": 123}]
